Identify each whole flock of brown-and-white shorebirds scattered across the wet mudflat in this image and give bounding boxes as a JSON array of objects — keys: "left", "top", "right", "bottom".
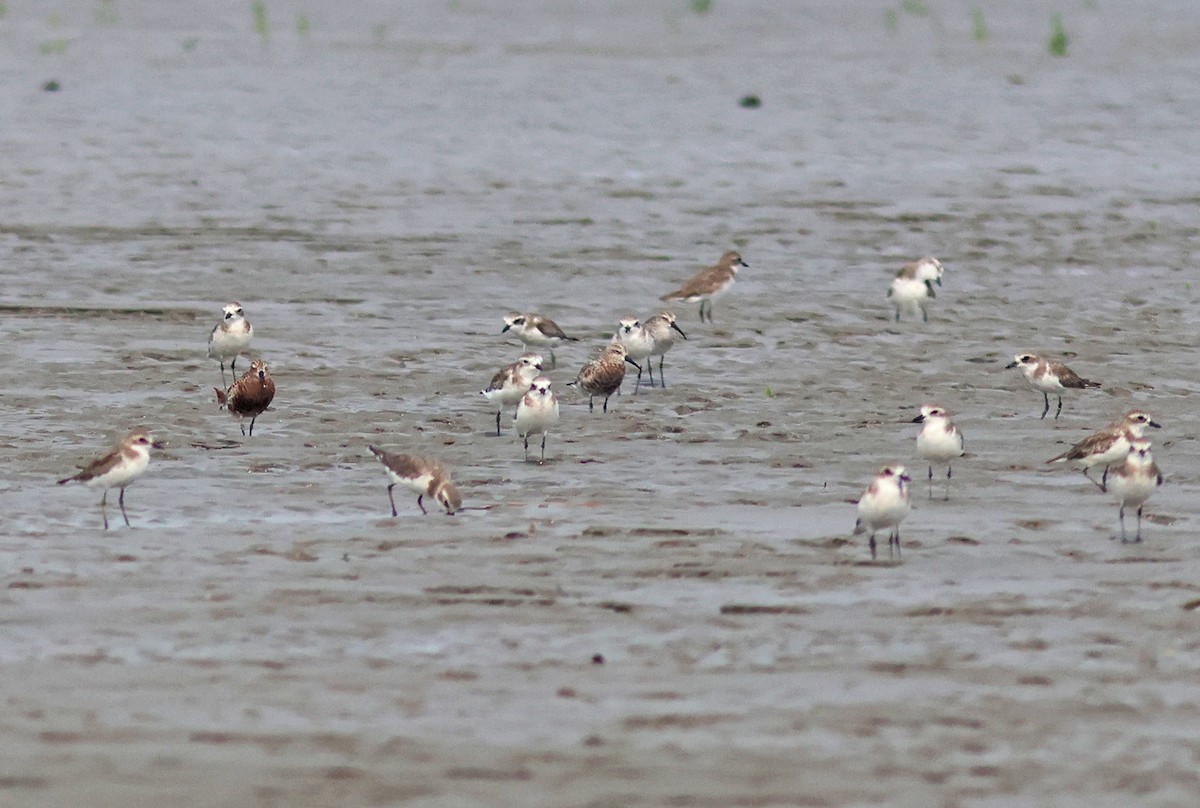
[{"left": 59, "top": 251, "right": 1163, "bottom": 559}]
